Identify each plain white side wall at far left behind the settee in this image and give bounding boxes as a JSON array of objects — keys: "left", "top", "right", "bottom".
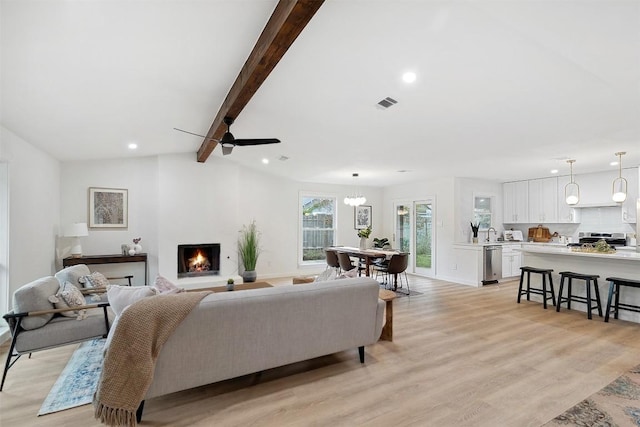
[{"left": 0, "top": 126, "right": 60, "bottom": 304}]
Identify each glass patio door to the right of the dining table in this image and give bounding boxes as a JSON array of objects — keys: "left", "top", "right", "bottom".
[{"left": 393, "top": 200, "right": 435, "bottom": 277}]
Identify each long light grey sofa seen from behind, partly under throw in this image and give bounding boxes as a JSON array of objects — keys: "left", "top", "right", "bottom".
[{"left": 107, "top": 277, "right": 384, "bottom": 418}]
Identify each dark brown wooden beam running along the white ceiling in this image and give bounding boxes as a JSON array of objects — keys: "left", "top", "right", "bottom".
[{"left": 198, "top": 0, "right": 324, "bottom": 163}]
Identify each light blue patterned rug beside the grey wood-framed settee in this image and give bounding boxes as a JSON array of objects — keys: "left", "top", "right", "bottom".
[{"left": 38, "top": 338, "right": 105, "bottom": 416}]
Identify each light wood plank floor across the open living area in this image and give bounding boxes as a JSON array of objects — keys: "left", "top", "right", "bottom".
[{"left": 0, "top": 277, "right": 640, "bottom": 427}]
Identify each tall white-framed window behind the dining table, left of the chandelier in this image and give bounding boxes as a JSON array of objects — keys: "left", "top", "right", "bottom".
[{"left": 300, "top": 194, "right": 336, "bottom": 262}]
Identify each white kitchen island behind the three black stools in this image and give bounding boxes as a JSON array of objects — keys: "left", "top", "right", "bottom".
[{"left": 514, "top": 245, "right": 640, "bottom": 323}]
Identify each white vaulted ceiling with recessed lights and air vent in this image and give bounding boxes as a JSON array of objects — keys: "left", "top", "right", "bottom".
[{"left": 0, "top": 0, "right": 640, "bottom": 186}]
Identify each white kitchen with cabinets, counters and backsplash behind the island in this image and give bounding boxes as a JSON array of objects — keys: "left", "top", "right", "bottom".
[{"left": 451, "top": 167, "right": 640, "bottom": 298}]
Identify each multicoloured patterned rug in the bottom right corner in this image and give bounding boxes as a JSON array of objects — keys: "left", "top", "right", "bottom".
[{"left": 544, "top": 365, "right": 640, "bottom": 427}]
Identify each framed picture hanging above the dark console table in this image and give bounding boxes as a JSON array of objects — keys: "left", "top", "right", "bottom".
[{"left": 88, "top": 187, "right": 129, "bottom": 228}]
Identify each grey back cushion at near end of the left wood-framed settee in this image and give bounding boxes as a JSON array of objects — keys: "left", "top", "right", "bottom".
[{"left": 13, "top": 276, "right": 60, "bottom": 330}]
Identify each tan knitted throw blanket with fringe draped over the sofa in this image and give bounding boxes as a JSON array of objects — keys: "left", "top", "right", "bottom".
[{"left": 93, "top": 292, "right": 211, "bottom": 427}]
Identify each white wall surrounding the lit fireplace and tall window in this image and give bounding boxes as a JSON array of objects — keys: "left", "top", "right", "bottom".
[{"left": 60, "top": 153, "right": 382, "bottom": 287}]
